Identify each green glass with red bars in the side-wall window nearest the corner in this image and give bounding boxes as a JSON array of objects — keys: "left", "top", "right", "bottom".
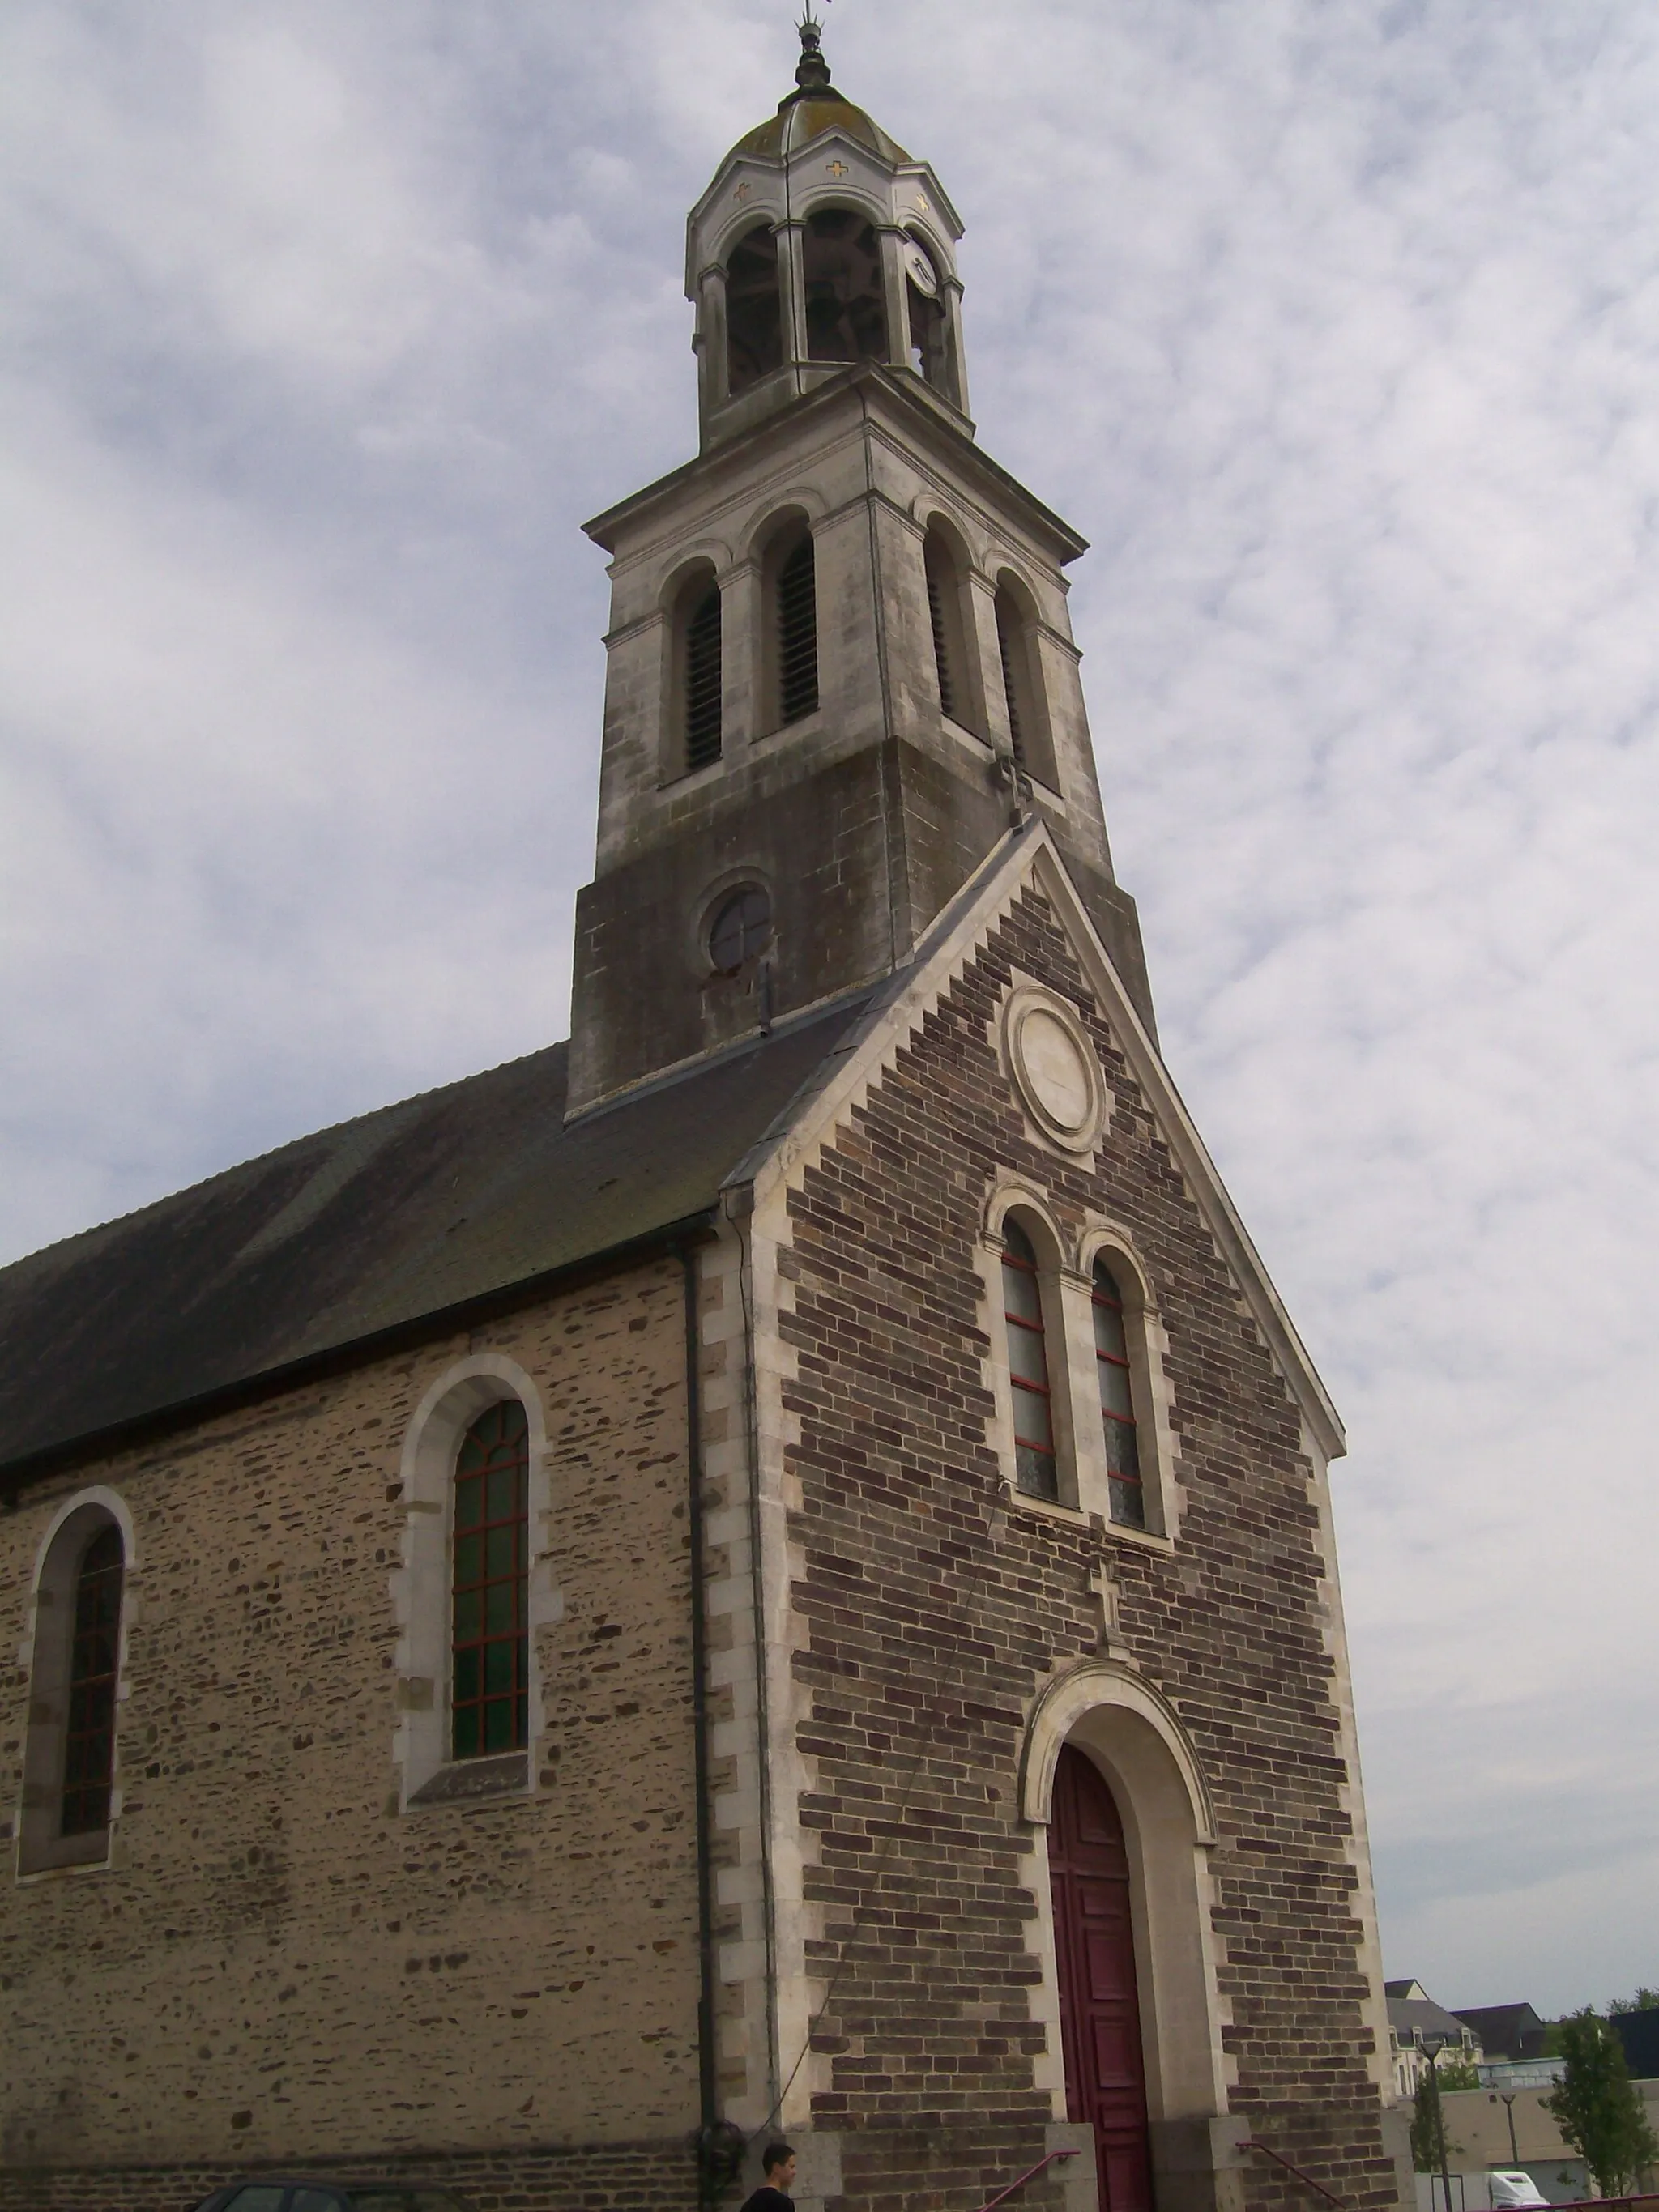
[{"left": 449, "top": 1398, "right": 531, "bottom": 1758}]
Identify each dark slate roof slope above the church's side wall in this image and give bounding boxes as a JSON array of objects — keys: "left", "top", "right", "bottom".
[{"left": 0, "top": 993, "right": 869, "bottom": 1482}]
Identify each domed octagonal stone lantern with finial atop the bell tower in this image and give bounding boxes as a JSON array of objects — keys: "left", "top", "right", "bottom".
[{"left": 686, "top": 18, "right": 971, "bottom": 447}]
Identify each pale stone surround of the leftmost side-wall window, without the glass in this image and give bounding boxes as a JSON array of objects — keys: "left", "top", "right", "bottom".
[{"left": 11, "top": 1485, "right": 137, "bottom": 1882}]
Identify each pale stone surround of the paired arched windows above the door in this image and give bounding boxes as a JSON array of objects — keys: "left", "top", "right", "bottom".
[{"left": 975, "top": 1174, "right": 1179, "bottom": 1550}]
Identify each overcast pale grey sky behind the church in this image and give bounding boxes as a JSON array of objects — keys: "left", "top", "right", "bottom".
[{"left": 0, "top": 0, "right": 1659, "bottom": 2010}]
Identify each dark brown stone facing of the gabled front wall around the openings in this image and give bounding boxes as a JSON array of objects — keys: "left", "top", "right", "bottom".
[{"left": 778, "top": 896, "right": 1396, "bottom": 2206}]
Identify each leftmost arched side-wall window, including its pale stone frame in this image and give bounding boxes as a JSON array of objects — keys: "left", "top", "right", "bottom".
[{"left": 18, "top": 1500, "right": 126, "bottom": 1873}]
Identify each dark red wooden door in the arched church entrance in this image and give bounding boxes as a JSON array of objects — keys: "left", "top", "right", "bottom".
[{"left": 1048, "top": 1747, "right": 1153, "bottom": 2212}]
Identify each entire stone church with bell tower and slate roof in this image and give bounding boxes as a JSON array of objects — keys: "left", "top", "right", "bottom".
[{"left": 0, "top": 22, "right": 1414, "bottom": 2212}]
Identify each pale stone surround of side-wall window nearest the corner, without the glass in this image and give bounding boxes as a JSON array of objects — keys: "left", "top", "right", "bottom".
[{"left": 390, "top": 1352, "right": 564, "bottom": 1812}]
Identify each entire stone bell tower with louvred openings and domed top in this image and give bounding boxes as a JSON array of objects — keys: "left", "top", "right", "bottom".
[{"left": 569, "top": 18, "right": 1150, "bottom": 1115}]
